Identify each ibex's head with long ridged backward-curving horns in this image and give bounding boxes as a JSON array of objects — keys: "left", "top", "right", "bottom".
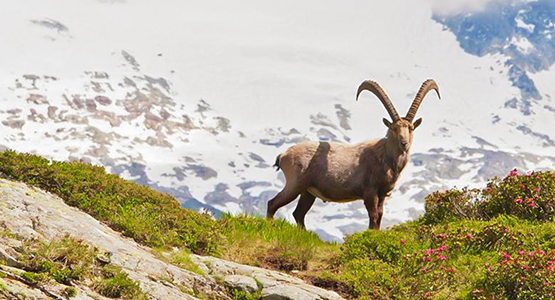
[{"left": 357, "top": 79, "right": 441, "bottom": 151}]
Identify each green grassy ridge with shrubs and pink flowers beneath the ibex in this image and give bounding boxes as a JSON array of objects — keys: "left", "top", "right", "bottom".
[{"left": 0, "top": 151, "right": 555, "bottom": 299}]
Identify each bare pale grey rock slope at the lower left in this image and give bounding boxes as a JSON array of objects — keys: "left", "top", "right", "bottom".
[{"left": 0, "top": 179, "right": 341, "bottom": 300}]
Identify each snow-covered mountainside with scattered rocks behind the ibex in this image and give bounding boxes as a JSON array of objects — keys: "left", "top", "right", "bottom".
[{"left": 0, "top": 0, "right": 555, "bottom": 239}]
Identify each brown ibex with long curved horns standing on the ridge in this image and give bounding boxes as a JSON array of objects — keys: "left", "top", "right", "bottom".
[{"left": 267, "top": 79, "right": 441, "bottom": 229}]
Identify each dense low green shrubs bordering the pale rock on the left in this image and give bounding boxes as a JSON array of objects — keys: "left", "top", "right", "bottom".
[{"left": 0, "top": 151, "right": 221, "bottom": 254}]
